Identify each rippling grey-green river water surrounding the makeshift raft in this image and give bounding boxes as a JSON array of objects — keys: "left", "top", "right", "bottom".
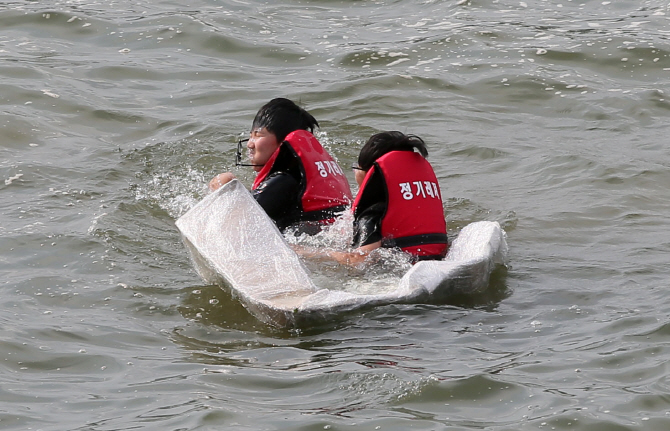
[{"left": 0, "top": 0, "right": 670, "bottom": 431}]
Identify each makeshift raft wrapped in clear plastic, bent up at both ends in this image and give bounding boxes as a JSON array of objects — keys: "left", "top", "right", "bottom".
[{"left": 176, "top": 180, "right": 507, "bottom": 326}]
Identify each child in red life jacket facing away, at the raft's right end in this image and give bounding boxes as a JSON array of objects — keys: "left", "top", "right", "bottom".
[{"left": 328, "top": 132, "right": 448, "bottom": 264}]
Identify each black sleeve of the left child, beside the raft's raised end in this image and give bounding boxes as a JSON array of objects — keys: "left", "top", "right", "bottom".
[{"left": 252, "top": 172, "right": 300, "bottom": 222}]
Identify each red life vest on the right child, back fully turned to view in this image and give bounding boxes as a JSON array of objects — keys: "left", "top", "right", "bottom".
[{"left": 353, "top": 151, "right": 448, "bottom": 258}]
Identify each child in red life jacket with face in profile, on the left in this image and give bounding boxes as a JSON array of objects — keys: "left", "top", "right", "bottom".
[{"left": 209, "top": 98, "right": 353, "bottom": 234}]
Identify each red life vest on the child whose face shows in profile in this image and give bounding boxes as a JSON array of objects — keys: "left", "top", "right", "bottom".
[{"left": 252, "top": 130, "right": 353, "bottom": 221}]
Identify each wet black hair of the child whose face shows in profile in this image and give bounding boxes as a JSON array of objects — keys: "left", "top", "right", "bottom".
[{"left": 251, "top": 97, "right": 319, "bottom": 142}]
